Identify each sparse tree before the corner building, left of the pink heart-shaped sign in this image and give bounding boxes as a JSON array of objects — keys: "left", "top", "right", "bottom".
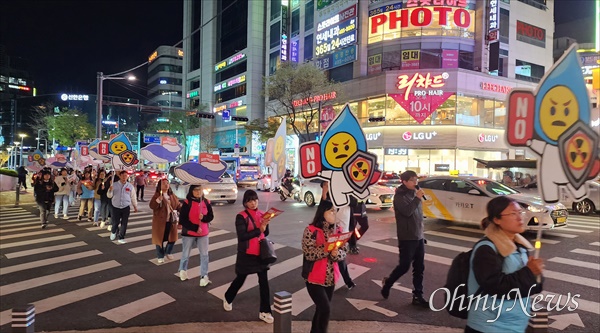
[{"left": 264, "top": 62, "right": 341, "bottom": 142}]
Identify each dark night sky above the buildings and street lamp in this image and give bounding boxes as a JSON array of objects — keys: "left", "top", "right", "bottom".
[{"left": 0, "top": 0, "right": 594, "bottom": 99}]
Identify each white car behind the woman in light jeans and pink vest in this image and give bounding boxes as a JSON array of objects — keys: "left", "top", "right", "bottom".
[{"left": 169, "top": 172, "right": 238, "bottom": 204}]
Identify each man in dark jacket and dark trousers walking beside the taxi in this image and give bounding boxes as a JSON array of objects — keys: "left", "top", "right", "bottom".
[{"left": 381, "top": 170, "right": 429, "bottom": 308}]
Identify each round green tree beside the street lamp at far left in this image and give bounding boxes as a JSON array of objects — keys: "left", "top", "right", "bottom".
[{"left": 46, "top": 108, "right": 96, "bottom": 147}]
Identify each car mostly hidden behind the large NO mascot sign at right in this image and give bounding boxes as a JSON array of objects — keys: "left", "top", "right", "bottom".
[{"left": 516, "top": 179, "right": 600, "bottom": 215}]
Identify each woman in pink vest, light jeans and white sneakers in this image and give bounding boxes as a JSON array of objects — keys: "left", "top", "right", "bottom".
[{"left": 177, "top": 183, "right": 214, "bottom": 287}]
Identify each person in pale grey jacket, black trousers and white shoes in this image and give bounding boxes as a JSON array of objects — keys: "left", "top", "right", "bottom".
[{"left": 106, "top": 170, "right": 137, "bottom": 244}]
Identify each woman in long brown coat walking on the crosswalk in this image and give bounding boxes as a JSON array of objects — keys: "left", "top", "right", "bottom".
[{"left": 150, "top": 179, "right": 181, "bottom": 264}]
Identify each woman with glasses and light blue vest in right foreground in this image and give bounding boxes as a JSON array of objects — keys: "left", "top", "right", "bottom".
[{"left": 465, "top": 196, "right": 544, "bottom": 332}]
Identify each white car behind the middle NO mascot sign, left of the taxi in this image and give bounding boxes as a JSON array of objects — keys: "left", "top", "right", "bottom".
[{"left": 300, "top": 179, "right": 394, "bottom": 210}]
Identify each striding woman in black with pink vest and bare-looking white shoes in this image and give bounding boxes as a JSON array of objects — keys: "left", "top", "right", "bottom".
[{"left": 223, "top": 190, "right": 273, "bottom": 324}]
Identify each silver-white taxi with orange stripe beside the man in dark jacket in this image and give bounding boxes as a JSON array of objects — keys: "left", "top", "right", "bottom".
[{"left": 419, "top": 176, "right": 568, "bottom": 230}]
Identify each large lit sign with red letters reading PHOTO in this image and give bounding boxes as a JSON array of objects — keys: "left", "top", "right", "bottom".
[{"left": 368, "top": 4, "right": 475, "bottom": 44}]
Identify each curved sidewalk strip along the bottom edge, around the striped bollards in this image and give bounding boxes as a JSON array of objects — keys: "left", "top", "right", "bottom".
[{"left": 44, "top": 320, "right": 463, "bottom": 333}]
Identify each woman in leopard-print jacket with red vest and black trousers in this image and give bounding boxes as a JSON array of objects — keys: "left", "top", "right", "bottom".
[{"left": 302, "top": 200, "right": 347, "bottom": 333}]
